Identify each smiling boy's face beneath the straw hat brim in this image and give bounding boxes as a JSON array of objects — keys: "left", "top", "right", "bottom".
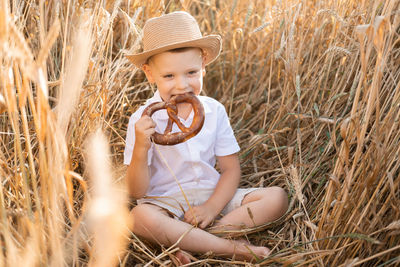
[{"left": 143, "top": 48, "right": 205, "bottom": 101}]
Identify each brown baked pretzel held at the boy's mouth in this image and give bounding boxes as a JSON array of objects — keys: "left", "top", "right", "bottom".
[{"left": 142, "top": 93, "right": 204, "bottom": 146}]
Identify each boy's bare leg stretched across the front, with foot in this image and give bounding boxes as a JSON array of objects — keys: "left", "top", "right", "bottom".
[{"left": 132, "top": 204, "right": 269, "bottom": 260}]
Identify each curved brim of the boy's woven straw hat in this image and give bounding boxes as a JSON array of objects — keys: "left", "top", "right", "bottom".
[{"left": 125, "top": 35, "right": 222, "bottom": 68}]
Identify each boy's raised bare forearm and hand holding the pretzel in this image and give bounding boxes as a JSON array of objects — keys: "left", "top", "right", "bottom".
[{"left": 126, "top": 116, "right": 155, "bottom": 198}]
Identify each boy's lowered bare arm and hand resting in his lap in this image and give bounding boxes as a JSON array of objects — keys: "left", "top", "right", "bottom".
[{"left": 184, "top": 154, "right": 240, "bottom": 228}]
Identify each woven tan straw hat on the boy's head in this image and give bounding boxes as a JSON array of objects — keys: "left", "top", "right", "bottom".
[{"left": 126, "top": 11, "right": 222, "bottom": 68}]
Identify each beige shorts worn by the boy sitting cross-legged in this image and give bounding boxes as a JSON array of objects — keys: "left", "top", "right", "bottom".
[{"left": 137, "top": 188, "right": 258, "bottom": 219}]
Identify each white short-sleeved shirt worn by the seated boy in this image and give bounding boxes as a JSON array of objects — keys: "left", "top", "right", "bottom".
[{"left": 124, "top": 91, "right": 240, "bottom": 196}]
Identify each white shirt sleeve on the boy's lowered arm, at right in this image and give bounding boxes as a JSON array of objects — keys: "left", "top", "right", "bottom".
[{"left": 215, "top": 104, "right": 240, "bottom": 156}]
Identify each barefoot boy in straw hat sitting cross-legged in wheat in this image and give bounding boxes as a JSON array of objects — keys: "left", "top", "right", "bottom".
[{"left": 124, "top": 12, "right": 288, "bottom": 263}]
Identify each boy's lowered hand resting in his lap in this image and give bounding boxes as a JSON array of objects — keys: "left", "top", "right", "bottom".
[{"left": 184, "top": 204, "right": 218, "bottom": 229}]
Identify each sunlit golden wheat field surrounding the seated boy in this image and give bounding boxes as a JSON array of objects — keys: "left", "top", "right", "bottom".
[{"left": 0, "top": 0, "right": 400, "bottom": 266}]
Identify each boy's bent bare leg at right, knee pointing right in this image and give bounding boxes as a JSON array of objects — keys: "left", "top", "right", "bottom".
[{"left": 215, "top": 187, "right": 288, "bottom": 230}]
